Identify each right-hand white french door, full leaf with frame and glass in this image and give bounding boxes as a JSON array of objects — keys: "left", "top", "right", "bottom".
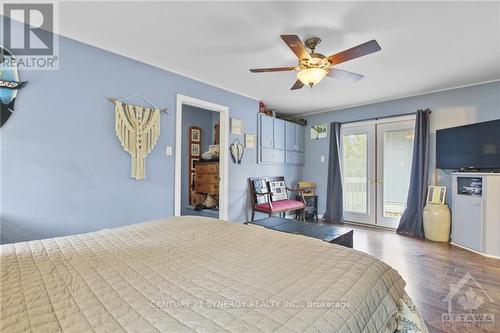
[{"left": 376, "top": 120, "right": 415, "bottom": 228}]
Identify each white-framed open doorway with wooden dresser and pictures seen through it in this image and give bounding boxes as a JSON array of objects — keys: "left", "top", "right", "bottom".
[{"left": 174, "top": 95, "right": 229, "bottom": 220}]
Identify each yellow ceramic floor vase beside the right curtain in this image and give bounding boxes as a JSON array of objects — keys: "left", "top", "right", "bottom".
[{"left": 424, "top": 203, "right": 451, "bottom": 242}]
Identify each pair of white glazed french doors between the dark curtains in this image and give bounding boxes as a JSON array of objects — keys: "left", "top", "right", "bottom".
[{"left": 341, "top": 117, "right": 415, "bottom": 228}]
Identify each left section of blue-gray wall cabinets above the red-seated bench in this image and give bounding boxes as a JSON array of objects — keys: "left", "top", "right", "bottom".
[{"left": 259, "top": 114, "right": 285, "bottom": 163}]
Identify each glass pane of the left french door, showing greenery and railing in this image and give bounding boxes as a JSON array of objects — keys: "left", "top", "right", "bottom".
[{"left": 342, "top": 133, "right": 368, "bottom": 214}]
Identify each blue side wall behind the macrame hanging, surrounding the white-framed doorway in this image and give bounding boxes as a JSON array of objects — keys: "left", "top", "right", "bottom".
[{"left": 0, "top": 22, "right": 301, "bottom": 243}]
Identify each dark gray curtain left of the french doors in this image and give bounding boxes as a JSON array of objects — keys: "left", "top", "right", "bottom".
[{"left": 323, "top": 122, "right": 344, "bottom": 223}]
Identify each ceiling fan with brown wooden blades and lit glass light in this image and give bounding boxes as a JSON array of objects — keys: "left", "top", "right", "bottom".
[{"left": 250, "top": 35, "right": 381, "bottom": 90}]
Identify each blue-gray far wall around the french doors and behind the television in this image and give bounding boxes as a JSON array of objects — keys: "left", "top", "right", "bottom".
[{"left": 303, "top": 81, "right": 500, "bottom": 214}]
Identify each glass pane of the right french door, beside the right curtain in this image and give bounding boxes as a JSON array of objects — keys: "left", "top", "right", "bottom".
[{"left": 383, "top": 129, "right": 415, "bottom": 218}]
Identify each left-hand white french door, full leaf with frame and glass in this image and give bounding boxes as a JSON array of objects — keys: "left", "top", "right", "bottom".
[{"left": 340, "top": 124, "right": 376, "bottom": 224}]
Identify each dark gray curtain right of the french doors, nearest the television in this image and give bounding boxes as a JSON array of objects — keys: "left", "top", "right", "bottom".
[{"left": 397, "top": 109, "right": 431, "bottom": 239}]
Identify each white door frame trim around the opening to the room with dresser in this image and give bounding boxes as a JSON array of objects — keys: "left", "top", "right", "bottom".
[{"left": 174, "top": 94, "right": 229, "bottom": 220}]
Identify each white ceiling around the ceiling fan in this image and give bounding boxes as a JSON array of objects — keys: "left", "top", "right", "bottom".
[{"left": 59, "top": 1, "right": 500, "bottom": 114}]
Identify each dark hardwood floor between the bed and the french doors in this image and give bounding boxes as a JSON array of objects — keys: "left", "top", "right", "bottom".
[{"left": 349, "top": 225, "right": 500, "bottom": 332}]
